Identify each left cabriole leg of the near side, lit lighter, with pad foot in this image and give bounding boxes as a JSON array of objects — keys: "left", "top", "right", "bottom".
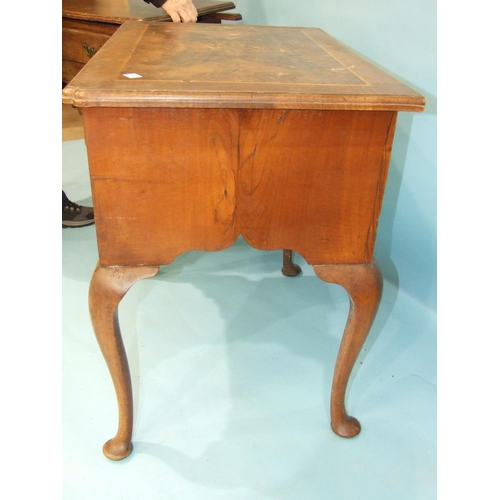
[{"left": 89, "top": 263, "right": 159, "bottom": 460}]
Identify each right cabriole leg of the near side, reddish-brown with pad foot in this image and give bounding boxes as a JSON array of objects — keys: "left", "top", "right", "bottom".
[{"left": 313, "top": 263, "right": 383, "bottom": 437}]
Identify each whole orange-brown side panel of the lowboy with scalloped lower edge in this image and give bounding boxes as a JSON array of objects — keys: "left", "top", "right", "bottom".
[{"left": 83, "top": 108, "right": 396, "bottom": 265}]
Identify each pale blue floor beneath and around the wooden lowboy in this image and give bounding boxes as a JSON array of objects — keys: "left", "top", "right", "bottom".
[{"left": 62, "top": 141, "right": 436, "bottom": 500}]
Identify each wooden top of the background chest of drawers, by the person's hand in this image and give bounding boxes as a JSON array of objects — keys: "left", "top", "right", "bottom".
[{"left": 62, "top": 0, "right": 235, "bottom": 24}]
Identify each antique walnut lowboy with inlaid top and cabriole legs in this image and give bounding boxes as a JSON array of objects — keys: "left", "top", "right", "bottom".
[{"left": 63, "top": 22, "right": 424, "bottom": 460}]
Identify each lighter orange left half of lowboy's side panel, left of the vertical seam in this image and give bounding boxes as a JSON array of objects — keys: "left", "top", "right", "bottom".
[{"left": 83, "top": 108, "right": 238, "bottom": 266}]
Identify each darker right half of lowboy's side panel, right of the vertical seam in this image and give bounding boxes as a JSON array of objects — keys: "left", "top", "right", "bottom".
[{"left": 236, "top": 110, "right": 396, "bottom": 264}]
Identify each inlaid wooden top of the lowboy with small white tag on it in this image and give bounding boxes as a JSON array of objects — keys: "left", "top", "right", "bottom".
[{"left": 63, "top": 22, "right": 425, "bottom": 111}]
